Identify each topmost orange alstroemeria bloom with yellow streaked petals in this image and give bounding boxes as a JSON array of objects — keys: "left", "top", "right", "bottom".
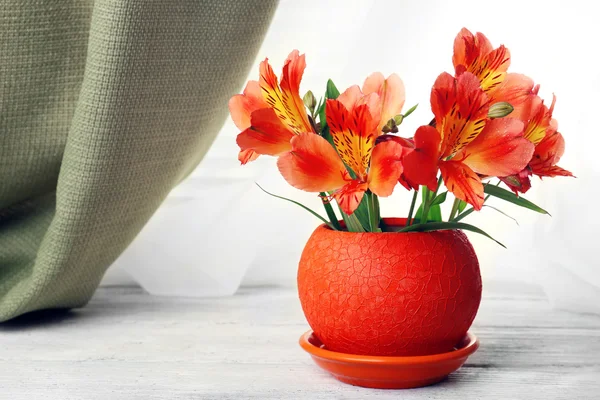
[{"left": 452, "top": 28, "right": 533, "bottom": 107}]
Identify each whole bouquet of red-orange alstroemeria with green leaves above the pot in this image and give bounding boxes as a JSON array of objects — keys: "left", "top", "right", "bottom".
[{"left": 229, "top": 29, "right": 572, "bottom": 245}]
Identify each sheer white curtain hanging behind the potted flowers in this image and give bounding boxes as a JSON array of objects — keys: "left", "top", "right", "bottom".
[{"left": 107, "top": 0, "right": 600, "bottom": 311}]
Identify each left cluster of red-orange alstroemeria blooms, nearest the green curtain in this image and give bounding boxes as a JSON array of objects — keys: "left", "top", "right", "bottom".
[{"left": 229, "top": 50, "right": 404, "bottom": 214}]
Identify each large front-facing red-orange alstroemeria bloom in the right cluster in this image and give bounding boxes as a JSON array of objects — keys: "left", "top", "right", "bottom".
[{"left": 403, "top": 72, "right": 534, "bottom": 210}]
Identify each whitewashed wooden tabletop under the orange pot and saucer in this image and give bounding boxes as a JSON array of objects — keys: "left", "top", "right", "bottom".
[{"left": 0, "top": 284, "right": 600, "bottom": 400}]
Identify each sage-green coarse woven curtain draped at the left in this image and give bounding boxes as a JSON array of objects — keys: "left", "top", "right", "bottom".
[{"left": 0, "top": 0, "right": 276, "bottom": 321}]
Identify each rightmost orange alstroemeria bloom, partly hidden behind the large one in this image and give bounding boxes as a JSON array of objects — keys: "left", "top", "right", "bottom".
[{"left": 500, "top": 90, "right": 573, "bottom": 194}]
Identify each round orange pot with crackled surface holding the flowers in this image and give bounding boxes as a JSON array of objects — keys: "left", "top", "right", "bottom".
[{"left": 298, "top": 218, "right": 481, "bottom": 356}]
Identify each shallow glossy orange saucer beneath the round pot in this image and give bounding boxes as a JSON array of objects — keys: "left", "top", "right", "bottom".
[{"left": 300, "top": 331, "right": 479, "bottom": 389}]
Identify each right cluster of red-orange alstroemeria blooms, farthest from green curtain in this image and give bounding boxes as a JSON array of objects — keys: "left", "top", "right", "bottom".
[{"left": 396, "top": 29, "right": 571, "bottom": 206}]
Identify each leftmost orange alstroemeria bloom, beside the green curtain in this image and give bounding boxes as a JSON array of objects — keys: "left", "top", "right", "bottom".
[{"left": 229, "top": 50, "right": 313, "bottom": 164}]
